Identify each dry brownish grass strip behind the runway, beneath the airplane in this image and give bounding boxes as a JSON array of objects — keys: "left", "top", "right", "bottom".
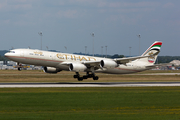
[{"left": 0, "top": 70, "right": 180, "bottom": 82}]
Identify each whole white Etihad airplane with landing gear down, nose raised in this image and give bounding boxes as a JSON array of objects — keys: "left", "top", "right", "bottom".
[{"left": 5, "top": 41, "right": 162, "bottom": 81}]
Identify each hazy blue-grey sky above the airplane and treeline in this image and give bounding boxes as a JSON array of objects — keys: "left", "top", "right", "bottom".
[{"left": 0, "top": 0, "right": 180, "bottom": 56}]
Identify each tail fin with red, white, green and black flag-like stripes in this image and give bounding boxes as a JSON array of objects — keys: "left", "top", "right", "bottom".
[{"left": 140, "top": 41, "right": 162, "bottom": 65}]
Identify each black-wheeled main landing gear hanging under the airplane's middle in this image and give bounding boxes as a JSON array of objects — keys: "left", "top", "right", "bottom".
[{"left": 74, "top": 72, "right": 99, "bottom": 81}]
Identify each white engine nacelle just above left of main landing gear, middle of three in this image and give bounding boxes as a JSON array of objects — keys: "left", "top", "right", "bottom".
[{"left": 69, "top": 63, "right": 87, "bottom": 72}]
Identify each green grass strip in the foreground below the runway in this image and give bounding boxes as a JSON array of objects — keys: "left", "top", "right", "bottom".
[{"left": 0, "top": 87, "right": 180, "bottom": 120}]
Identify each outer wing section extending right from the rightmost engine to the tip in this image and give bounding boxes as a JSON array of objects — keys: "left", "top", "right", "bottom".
[{"left": 114, "top": 56, "right": 149, "bottom": 64}]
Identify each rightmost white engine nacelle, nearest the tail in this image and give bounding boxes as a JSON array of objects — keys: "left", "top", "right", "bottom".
[{"left": 100, "top": 60, "right": 118, "bottom": 68}]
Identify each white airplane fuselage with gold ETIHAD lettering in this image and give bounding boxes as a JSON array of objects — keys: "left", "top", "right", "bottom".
[{"left": 5, "top": 49, "right": 147, "bottom": 74}]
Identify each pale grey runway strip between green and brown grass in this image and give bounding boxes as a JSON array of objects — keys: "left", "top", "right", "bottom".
[{"left": 0, "top": 82, "right": 180, "bottom": 88}]
